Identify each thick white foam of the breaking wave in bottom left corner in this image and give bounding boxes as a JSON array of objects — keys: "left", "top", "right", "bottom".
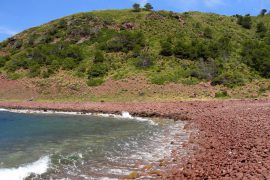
[{"left": 0, "top": 156, "right": 50, "bottom": 180}]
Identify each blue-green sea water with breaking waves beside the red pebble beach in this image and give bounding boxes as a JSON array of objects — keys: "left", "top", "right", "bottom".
[{"left": 0, "top": 111, "right": 188, "bottom": 179}]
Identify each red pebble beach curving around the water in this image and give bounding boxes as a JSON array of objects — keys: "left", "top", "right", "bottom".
[{"left": 0, "top": 99, "right": 270, "bottom": 180}]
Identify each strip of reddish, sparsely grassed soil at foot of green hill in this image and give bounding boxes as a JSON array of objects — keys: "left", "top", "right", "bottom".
[{"left": 0, "top": 72, "right": 270, "bottom": 102}]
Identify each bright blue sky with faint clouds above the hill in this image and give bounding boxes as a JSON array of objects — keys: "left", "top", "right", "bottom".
[{"left": 0, "top": 0, "right": 270, "bottom": 41}]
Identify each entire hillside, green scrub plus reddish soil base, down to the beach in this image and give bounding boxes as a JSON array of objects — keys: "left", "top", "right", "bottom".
[{"left": 0, "top": 9, "right": 270, "bottom": 100}]
